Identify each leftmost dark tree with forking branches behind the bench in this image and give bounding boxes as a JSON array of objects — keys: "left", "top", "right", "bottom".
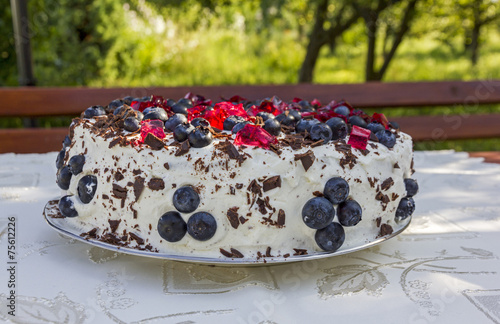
[{"left": 299, "top": 0, "right": 360, "bottom": 83}]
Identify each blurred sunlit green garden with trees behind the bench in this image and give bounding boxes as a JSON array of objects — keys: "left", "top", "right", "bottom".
[{"left": 0, "top": 0, "right": 500, "bottom": 151}]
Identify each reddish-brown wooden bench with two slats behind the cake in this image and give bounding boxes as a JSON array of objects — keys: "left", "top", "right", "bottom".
[{"left": 0, "top": 80, "right": 500, "bottom": 160}]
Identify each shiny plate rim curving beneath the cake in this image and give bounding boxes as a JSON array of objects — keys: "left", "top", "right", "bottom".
[{"left": 43, "top": 200, "right": 411, "bottom": 265}]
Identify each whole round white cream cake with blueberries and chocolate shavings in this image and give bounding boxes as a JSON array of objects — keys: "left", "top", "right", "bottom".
[{"left": 51, "top": 94, "right": 418, "bottom": 261}]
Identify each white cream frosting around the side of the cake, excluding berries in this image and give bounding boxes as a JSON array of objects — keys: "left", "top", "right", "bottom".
[{"left": 63, "top": 120, "right": 412, "bottom": 258}]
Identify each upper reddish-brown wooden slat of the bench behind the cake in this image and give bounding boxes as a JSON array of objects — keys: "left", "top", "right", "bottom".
[{"left": 0, "top": 80, "right": 500, "bottom": 117}]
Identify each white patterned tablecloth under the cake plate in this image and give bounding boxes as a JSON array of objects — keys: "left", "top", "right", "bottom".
[{"left": 0, "top": 151, "right": 500, "bottom": 323}]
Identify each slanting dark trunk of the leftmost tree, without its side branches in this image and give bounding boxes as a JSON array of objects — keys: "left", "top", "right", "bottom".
[{"left": 299, "top": 0, "right": 328, "bottom": 83}]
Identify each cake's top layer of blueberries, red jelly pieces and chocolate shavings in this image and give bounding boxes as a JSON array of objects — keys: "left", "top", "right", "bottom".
[{"left": 70, "top": 93, "right": 406, "bottom": 162}]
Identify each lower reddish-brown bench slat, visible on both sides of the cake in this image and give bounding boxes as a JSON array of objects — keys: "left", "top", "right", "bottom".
[{"left": 0, "top": 114, "right": 500, "bottom": 153}]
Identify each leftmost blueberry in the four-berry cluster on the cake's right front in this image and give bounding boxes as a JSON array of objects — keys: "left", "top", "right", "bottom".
[{"left": 302, "top": 197, "right": 335, "bottom": 229}]
